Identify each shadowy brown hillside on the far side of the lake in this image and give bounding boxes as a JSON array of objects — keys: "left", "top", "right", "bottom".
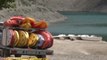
[{"left": 45, "top": 0, "right": 107, "bottom": 12}]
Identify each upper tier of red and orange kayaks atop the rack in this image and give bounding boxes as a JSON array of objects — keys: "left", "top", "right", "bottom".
[{"left": 4, "top": 16, "right": 48, "bottom": 29}]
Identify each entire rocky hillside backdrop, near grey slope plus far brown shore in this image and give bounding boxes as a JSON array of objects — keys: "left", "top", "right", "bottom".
[{"left": 0, "top": 0, "right": 107, "bottom": 22}]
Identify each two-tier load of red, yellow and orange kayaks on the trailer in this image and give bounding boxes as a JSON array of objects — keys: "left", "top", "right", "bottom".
[{"left": 2, "top": 16, "right": 53, "bottom": 49}]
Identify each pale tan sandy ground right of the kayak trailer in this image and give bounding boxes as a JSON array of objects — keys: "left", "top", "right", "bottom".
[{"left": 47, "top": 40, "right": 107, "bottom": 60}]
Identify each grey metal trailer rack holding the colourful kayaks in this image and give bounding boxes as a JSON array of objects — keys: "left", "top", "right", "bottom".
[{"left": 0, "top": 27, "right": 53, "bottom": 58}]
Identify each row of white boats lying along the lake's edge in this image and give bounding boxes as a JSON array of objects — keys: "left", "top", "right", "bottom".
[{"left": 53, "top": 34, "right": 103, "bottom": 41}]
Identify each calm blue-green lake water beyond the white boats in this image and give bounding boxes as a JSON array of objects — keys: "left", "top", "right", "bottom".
[{"left": 48, "top": 12, "right": 107, "bottom": 40}]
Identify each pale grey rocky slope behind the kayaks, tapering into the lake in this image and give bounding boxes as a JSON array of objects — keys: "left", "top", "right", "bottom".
[{"left": 0, "top": 0, "right": 66, "bottom": 22}]
